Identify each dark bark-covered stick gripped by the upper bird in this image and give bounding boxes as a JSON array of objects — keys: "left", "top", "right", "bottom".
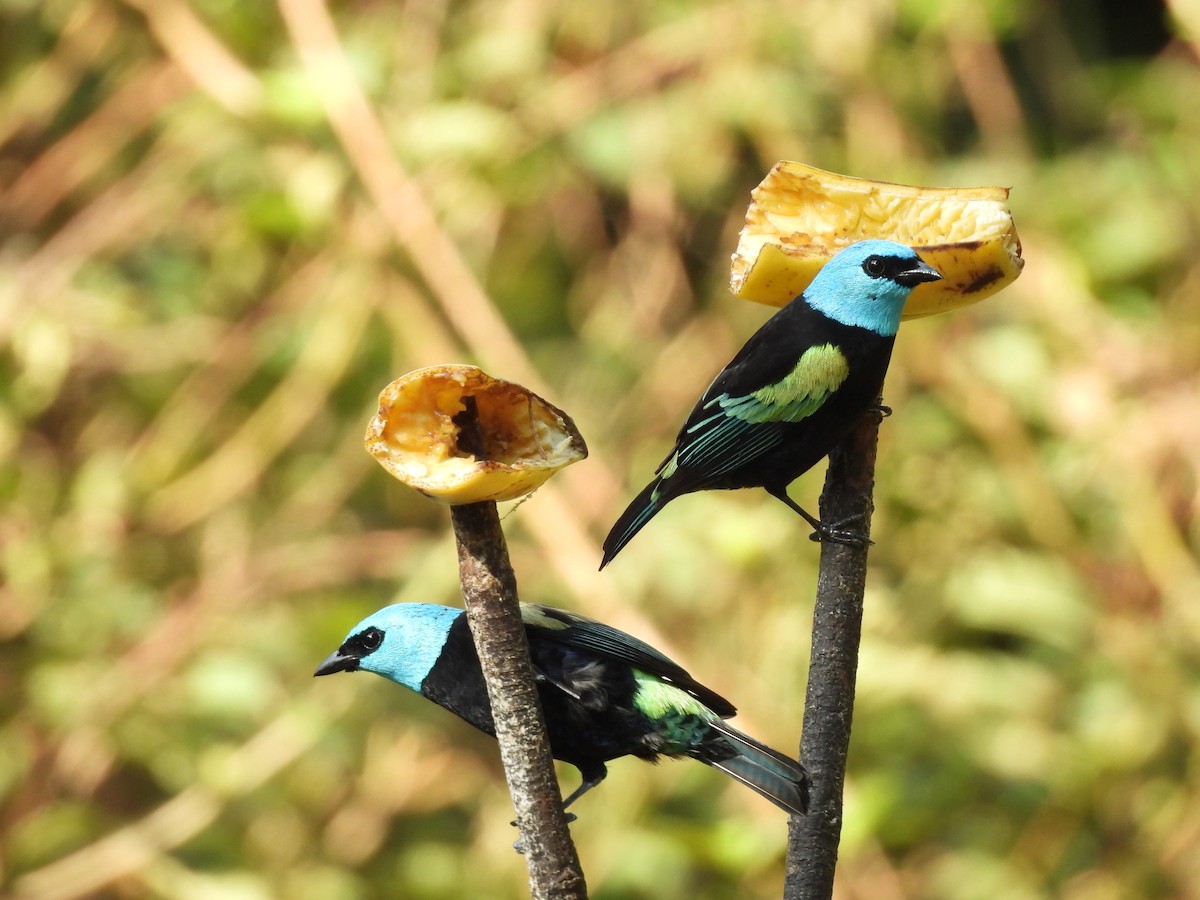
[{"left": 784, "top": 415, "right": 880, "bottom": 900}]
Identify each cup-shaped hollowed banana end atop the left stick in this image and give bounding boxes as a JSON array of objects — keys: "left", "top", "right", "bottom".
[{"left": 364, "top": 365, "right": 588, "bottom": 505}]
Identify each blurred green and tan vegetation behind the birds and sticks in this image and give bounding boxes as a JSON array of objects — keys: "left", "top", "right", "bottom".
[{"left": 0, "top": 0, "right": 1200, "bottom": 900}]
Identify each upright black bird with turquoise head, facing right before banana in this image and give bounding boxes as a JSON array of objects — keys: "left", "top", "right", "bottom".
[{"left": 600, "top": 240, "right": 942, "bottom": 569}]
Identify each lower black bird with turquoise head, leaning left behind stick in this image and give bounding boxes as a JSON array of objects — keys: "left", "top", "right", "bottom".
[{"left": 316, "top": 604, "right": 809, "bottom": 815}]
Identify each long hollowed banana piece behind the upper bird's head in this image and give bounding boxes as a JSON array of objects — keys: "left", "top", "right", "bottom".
[{"left": 730, "top": 161, "right": 1025, "bottom": 319}]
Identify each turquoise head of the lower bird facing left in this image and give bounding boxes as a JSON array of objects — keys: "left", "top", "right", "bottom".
[{"left": 313, "top": 604, "right": 463, "bottom": 691}]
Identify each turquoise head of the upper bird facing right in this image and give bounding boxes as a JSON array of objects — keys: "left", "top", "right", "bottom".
[{"left": 804, "top": 240, "right": 942, "bottom": 337}]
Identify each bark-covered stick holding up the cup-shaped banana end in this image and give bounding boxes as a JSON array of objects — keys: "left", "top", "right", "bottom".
[{"left": 450, "top": 398, "right": 587, "bottom": 900}]
